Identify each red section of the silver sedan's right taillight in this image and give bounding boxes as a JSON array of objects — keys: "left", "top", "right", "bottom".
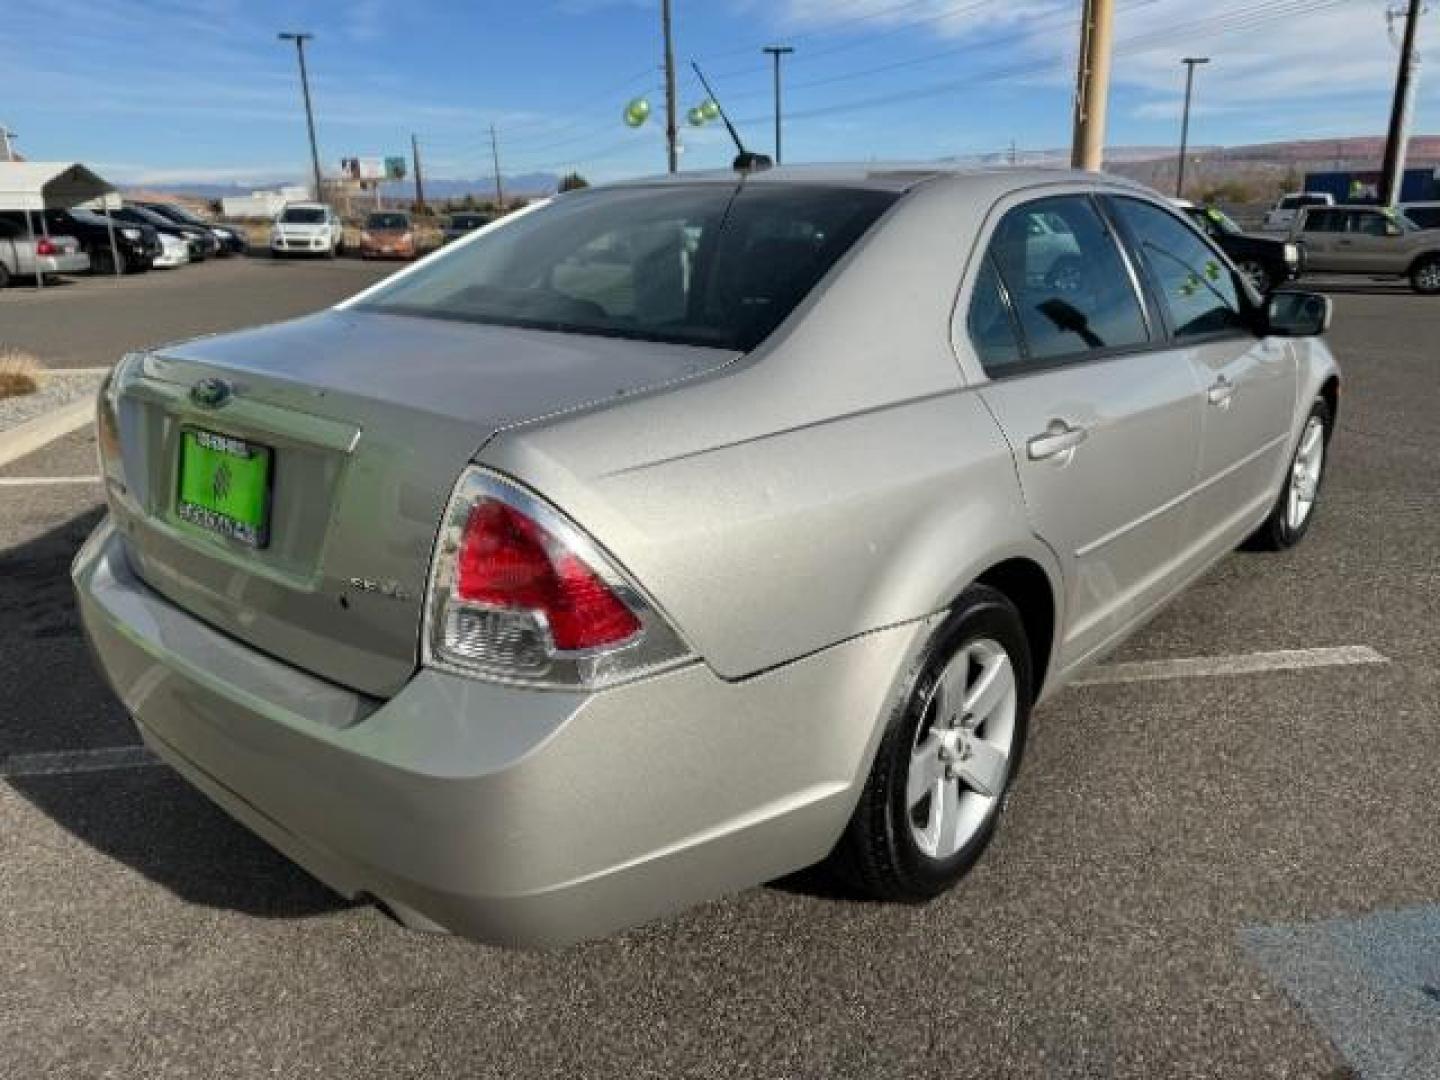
[{"left": 455, "top": 498, "right": 641, "bottom": 652}]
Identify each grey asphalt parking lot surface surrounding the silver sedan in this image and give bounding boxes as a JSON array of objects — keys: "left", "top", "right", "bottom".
[{"left": 0, "top": 262, "right": 1440, "bottom": 1080}]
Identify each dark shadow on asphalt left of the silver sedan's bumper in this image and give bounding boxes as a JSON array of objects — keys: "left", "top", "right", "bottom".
[{"left": 0, "top": 510, "right": 354, "bottom": 919}]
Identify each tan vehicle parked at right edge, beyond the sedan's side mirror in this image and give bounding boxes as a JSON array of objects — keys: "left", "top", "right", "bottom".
[{"left": 1290, "top": 206, "right": 1440, "bottom": 294}]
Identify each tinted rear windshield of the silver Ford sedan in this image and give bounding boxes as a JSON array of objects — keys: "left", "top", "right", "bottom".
[{"left": 361, "top": 184, "right": 897, "bottom": 351}]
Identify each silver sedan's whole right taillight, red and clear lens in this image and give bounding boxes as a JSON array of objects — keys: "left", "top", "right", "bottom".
[{"left": 425, "top": 468, "right": 688, "bottom": 687}]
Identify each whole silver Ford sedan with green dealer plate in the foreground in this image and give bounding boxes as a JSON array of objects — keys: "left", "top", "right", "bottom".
[{"left": 73, "top": 166, "right": 1341, "bottom": 945}]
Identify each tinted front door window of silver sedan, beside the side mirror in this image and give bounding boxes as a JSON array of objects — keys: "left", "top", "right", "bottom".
[{"left": 1112, "top": 199, "right": 1246, "bottom": 337}]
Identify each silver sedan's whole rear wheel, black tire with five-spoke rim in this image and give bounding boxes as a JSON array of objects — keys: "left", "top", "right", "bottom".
[{"left": 832, "top": 585, "right": 1032, "bottom": 903}]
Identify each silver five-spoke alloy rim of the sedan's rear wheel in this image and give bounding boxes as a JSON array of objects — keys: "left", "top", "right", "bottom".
[{"left": 906, "top": 638, "right": 1018, "bottom": 860}]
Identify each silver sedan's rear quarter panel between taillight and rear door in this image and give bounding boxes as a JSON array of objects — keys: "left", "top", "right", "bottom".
[{"left": 481, "top": 177, "right": 1054, "bottom": 678}]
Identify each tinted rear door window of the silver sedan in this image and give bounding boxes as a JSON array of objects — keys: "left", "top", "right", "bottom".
[{"left": 989, "top": 196, "right": 1149, "bottom": 361}]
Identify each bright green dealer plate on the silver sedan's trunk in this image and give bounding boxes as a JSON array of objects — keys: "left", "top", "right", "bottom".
[{"left": 176, "top": 428, "right": 274, "bottom": 547}]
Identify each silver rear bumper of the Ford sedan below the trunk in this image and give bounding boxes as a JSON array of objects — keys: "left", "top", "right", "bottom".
[{"left": 73, "top": 521, "right": 926, "bottom": 946}]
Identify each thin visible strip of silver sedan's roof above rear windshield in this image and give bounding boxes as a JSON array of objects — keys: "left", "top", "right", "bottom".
[{"left": 592, "top": 161, "right": 1149, "bottom": 193}]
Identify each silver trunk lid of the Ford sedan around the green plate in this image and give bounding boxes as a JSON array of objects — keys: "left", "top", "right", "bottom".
[{"left": 111, "top": 311, "right": 734, "bottom": 696}]
